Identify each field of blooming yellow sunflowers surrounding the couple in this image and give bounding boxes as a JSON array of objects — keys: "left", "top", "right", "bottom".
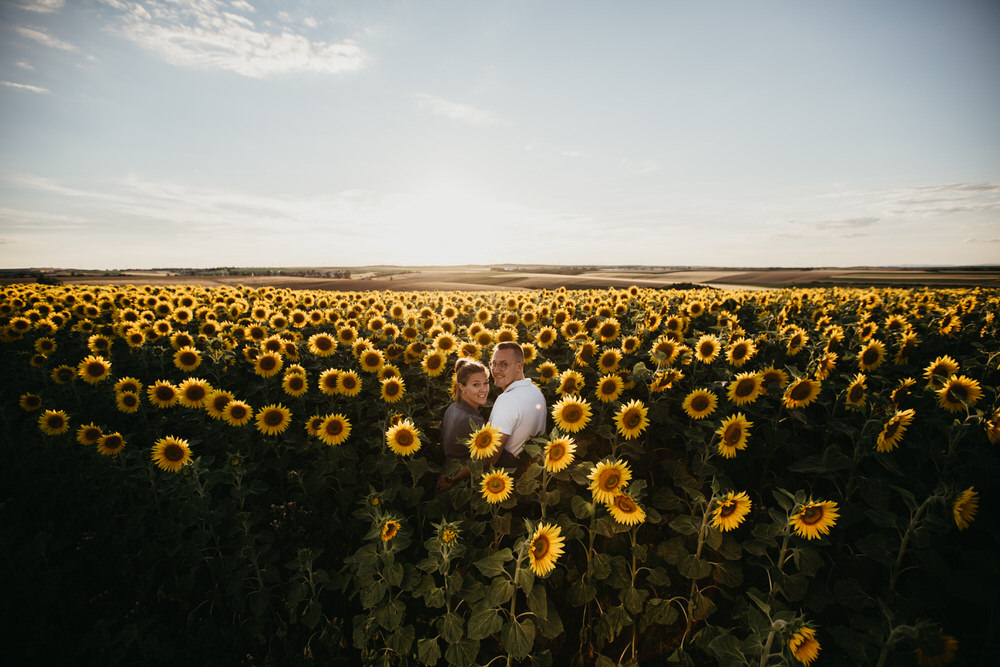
[{"left": 0, "top": 284, "right": 1000, "bottom": 667}]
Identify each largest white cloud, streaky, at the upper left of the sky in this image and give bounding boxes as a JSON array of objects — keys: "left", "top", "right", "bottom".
[{"left": 102, "top": 0, "right": 367, "bottom": 78}]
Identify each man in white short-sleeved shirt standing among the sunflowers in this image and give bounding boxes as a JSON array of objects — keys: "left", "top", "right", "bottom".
[{"left": 489, "top": 341, "right": 547, "bottom": 468}]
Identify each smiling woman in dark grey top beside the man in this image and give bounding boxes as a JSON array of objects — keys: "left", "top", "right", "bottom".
[{"left": 438, "top": 359, "right": 490, "bottom": 491}]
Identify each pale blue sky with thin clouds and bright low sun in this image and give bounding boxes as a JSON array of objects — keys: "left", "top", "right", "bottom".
[{"left": 0, "top": 0, "right": 1000, "bottom": 269}]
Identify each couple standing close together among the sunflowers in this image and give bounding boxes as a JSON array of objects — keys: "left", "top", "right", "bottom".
[{"left": 438, "top": 341, "right": 546, "bottom": 491}]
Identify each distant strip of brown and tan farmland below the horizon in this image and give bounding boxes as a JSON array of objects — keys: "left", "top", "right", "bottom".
[{"left": 21, "top": 267, "right": 1000, "bottom": 291}]
